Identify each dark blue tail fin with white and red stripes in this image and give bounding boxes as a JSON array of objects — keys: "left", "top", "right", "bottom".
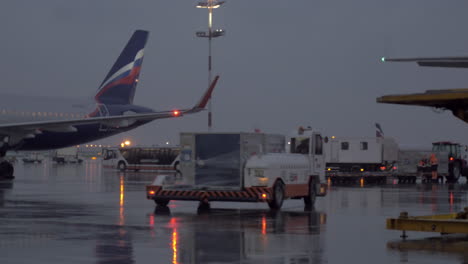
[{"left": 94, "top": 30, "right": 149, "bottom": 104}]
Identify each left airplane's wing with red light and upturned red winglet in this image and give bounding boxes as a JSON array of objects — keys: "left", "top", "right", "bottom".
[{"left": 0, "top": 76, "right": 219, "bottom": 138}]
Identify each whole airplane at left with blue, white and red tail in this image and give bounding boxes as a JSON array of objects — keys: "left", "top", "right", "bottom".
[{"left": 0, "top": 30, "right": 219, "bottom": 178}]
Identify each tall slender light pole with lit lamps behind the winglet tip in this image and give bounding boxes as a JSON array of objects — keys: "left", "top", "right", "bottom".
[{"left": 196, "top": 0, "right": 225, "bottom": 131}]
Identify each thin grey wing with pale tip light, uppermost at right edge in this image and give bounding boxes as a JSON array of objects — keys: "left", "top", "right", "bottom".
[{"left": 381, "top": 56, "right": 468, "bottom": 68}]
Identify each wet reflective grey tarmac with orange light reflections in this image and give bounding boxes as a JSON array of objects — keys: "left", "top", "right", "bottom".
[{"left": 0, "top": 161, "right": 468, "bottom": 264}]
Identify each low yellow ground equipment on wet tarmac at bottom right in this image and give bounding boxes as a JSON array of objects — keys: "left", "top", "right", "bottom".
[{"left": 387, "top": 207, "right": 468, "bottom": 238}]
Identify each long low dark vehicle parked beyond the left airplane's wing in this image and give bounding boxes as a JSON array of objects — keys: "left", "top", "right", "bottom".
[{"left": 102, "top": 147, "right": 180, "bottom": 172}]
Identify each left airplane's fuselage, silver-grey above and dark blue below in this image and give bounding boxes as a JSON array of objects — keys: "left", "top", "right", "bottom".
[{"left": 0, "top": 95, "right": 154, "bottom": 150}]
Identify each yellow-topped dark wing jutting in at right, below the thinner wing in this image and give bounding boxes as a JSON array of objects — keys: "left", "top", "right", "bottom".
[{"left": 377, "top": 89, "right": 468, "bottom": 110}]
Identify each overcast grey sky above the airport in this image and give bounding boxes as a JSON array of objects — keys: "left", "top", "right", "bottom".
[{"left": 0, "top": 0, "right": 468, "bottom": 144}]
